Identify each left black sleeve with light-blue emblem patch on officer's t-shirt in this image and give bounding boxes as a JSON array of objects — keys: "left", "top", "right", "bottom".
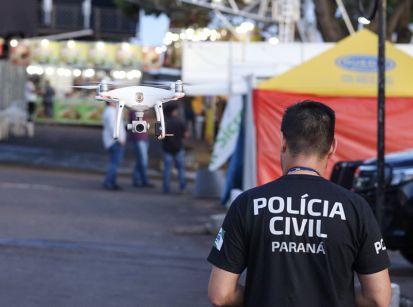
[{"left": 208, "top": 197, "right": 247, "bottom": 274}]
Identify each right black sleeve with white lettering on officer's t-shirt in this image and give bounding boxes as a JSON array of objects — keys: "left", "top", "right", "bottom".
[{"left": 354, "top": 199, "right": 390, "bottom": 274}]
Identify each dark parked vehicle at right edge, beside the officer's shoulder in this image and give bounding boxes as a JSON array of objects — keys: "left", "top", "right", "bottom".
[{"left": 331, "top": 150, "right": 413, "bottom": 263}]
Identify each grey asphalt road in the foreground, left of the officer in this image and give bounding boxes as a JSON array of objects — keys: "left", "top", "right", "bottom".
[{"left": 0, "top": 165, "right": 413, "bottom": 307}]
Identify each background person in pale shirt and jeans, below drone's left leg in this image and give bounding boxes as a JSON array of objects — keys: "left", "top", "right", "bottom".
[{"left": 102, "top": 102, "right": 126, "bottom": 191}]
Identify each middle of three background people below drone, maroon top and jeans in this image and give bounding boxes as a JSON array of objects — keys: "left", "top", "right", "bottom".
[{"left": 129, "top": 111, "right": 154, "bottom": 188}]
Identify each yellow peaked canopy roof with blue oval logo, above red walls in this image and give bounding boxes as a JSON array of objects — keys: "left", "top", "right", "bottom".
[{"left": 258, "top": 30, "right": 413, "bottom": 97}]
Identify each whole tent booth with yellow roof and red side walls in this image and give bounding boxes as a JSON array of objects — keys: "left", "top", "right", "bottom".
[{"left": 253, "top": 30, "right": 413, "bottom": 185}]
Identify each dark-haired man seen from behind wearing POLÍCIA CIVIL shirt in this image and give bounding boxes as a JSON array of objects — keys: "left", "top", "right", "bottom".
[{"left": 208, "top": 101, "right": 391, "bottom": 307}]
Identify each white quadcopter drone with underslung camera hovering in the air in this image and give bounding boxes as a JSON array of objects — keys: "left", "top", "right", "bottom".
[{"left": 74, "top": 80, "right": 185, "bottom": 140}]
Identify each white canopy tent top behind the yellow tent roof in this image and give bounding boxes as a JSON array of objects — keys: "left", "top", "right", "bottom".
[{"left": 182, "top": 42, "right": 413, "bottom": 96}]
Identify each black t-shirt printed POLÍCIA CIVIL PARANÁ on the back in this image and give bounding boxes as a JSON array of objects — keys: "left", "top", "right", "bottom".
[{"left": 208, "top": 175, "right": 389, "bottom": 307}]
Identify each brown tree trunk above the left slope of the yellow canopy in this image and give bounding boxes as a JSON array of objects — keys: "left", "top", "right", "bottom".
[{"left": 314, "top": 0, "right": 346, "bottom": 42}]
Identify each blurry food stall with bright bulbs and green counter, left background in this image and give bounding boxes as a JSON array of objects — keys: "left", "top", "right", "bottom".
[{"left": 9, "top": 39, "right": 143, "bottom": 125}]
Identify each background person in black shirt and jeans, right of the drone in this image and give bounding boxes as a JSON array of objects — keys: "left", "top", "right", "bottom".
[{"left": 162, "top": 104, "right": 187, "bottom": 193}]
